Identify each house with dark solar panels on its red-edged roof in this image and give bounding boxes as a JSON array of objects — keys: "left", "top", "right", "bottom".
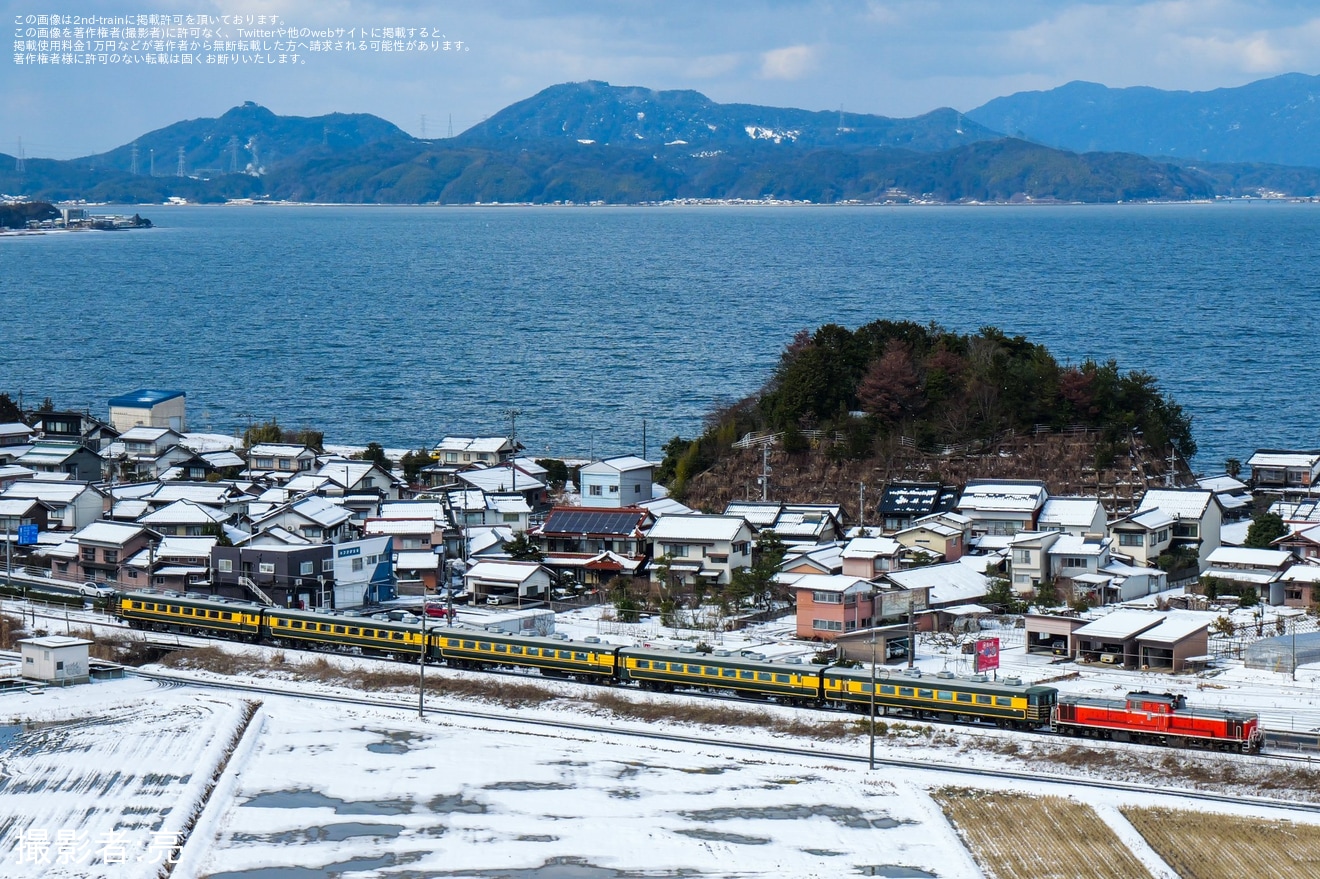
[{"left": 528, "top": 507, "right": 654, "bottom": 583}]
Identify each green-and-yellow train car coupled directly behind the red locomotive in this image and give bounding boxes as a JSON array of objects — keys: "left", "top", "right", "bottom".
[{"left": 824, "top": 668, "right": 1059, "bottom": 729}]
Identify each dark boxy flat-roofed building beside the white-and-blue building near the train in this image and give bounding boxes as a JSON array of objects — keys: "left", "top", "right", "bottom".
[{"left": 211, "top": 541, "right": 335, "bottom": 607}]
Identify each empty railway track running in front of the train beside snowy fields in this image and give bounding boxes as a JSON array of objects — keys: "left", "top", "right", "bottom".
[{"left": 126, "top": 670, "right": 1320, "bottom": 814}]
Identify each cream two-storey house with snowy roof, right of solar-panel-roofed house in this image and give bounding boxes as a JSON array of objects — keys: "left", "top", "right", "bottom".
[{"left": 647, "top": 513, "right": 752, "bottom": 585}]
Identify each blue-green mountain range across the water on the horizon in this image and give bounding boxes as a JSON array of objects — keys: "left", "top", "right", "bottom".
[{"left": 0, "top": 74, "right": 1320, "bottom": 203}]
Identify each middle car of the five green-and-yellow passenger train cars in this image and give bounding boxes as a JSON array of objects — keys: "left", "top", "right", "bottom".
[{"left": 430, "top": 628, "right": 619, "bottom": 681}]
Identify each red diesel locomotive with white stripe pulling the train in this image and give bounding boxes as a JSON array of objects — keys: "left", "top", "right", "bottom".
[{"left": 1052, "top": 693, "right": 1265, "bottom": 752}]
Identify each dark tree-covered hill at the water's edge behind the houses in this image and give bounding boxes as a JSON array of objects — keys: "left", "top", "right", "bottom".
[{"left": 660, "top": 321, "right": 1196, "bottom": 495}]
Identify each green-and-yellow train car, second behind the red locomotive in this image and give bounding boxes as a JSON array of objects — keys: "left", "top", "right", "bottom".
[{"left": 619, "top": 647, "right": 822, "bottom": 703}]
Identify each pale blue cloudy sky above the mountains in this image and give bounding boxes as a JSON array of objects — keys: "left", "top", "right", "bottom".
[{"left": 0, "top": 0, "right": 1320, "bottom": 158}]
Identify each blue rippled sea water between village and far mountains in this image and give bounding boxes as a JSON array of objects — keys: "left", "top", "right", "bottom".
[{"left": 0, "top": 203, "right": 1320, "bottom": 471}]
